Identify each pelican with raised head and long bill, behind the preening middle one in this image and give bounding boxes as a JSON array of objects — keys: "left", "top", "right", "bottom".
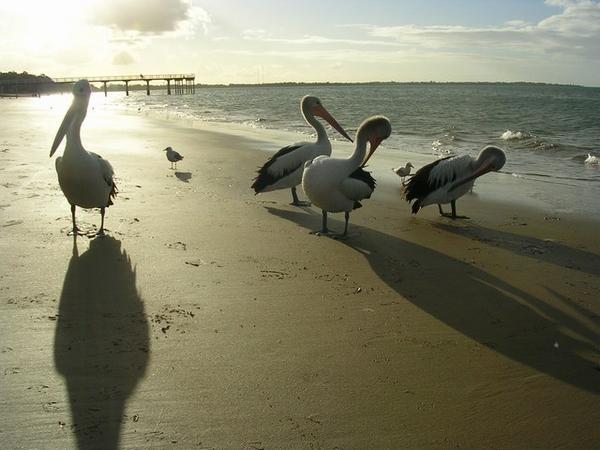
[{"left": 251, "top": 95, "right": 352, "bottom": 206}]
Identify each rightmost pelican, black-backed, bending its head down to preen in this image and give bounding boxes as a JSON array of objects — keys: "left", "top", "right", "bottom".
[{"left": 404, "top": 145, "right": 506, "bottom": 219}]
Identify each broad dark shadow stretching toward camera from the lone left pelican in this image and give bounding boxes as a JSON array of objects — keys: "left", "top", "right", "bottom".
[{"left": 54, "top": 236, "right": 149, "bottom": 449}]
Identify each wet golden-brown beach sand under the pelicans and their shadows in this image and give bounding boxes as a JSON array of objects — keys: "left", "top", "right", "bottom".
[{"left": 0, "top": 99, "right": 600, "bottom": 449}]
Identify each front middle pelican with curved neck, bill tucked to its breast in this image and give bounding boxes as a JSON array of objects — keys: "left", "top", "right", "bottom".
[{"left": 302, "top": 116, "right": 392, "bottom": 236}]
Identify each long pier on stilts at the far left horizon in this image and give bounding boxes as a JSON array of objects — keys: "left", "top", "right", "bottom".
[{"left": 0, "top": 73, "right": 196, "bottom": 97}]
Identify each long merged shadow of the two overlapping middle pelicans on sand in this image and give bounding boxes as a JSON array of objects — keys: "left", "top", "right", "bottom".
[{"left": 266, "top": 207, "right": 600, "bottom": 394}]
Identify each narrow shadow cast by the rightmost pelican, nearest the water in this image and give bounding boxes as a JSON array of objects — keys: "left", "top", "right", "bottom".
[{"left": 434, "top": 223, "right": 600, "bottom": 275}]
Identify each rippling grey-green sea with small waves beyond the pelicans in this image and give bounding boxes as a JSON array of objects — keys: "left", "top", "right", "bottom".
[{"left": 59, "top": 83, "right": 600, "bottom": 219}]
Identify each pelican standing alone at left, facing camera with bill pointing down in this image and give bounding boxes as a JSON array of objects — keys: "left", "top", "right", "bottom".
[{"left": 50, "top": 80, "right": 117, "bottom": 235}]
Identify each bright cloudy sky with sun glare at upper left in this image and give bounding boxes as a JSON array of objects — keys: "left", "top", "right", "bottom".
[{"left": 0, "top": 0, "right": 600, "bottom": 86}]
